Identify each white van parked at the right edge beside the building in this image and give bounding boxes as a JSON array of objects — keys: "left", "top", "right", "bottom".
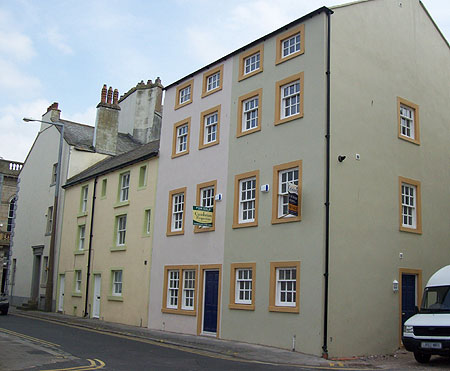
[{"left": 402, "top": 265, "right": 450, "bottom": 363}]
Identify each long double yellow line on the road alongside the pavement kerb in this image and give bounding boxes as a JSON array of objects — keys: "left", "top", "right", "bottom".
[{"left": 13, "top": 313, "right": 377, "bottom": 371}]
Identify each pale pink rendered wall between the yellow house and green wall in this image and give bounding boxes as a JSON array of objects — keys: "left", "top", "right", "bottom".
[{"left": 149, "top": 59, "right": 233, "bottom": 334}]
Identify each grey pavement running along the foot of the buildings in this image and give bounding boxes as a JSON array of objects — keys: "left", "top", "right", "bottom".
[{"left": 5, "top": 308, "right": 450, "bottom": 370}]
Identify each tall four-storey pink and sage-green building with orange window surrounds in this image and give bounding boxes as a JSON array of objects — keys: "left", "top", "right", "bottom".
[{"left": 149, "top": 0, "right": 450, "bottom": 357}]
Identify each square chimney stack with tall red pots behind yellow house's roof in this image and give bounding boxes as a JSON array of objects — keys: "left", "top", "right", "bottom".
[{"left": 93, "top": 84, "right": 120, "bottom": 155}]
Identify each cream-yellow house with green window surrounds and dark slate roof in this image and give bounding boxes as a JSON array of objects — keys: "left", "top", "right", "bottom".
[{"left": 57, "top": 141, "right": 159, "bottom": 326}]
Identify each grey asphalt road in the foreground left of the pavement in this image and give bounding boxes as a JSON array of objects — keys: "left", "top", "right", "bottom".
[{"left": 0, "top": 315, "right": 326, "bottom": 371}]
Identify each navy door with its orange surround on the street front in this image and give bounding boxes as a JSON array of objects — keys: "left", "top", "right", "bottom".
[{"left": 197, "top": 265, "right": 221, "bottom": 337}]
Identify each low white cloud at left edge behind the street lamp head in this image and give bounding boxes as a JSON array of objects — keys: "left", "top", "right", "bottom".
[{"left": 0, "top": 99, "right": 49, "bottom": 161}]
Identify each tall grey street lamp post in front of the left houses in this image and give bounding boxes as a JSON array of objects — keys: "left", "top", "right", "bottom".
[{"left": 23, "top": 117, "right": 64, "bottom": 312}]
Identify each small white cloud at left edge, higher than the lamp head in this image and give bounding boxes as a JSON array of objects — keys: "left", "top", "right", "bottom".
[{"left": 0, "top": 58, "right": 41, "bottom": 96}]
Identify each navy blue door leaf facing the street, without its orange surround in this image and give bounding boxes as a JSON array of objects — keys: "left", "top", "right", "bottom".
[{"left": 203, "top": 271, "right": 219, "bottom": 332}]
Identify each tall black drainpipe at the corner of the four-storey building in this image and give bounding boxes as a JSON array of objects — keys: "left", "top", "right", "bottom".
[{"left": 322, "top": 13, "right": 331, "bottom": 359}]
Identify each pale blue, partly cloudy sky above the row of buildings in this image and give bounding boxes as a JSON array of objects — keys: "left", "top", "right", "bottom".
[{"left": 0, "top": 0, "right": 450, "bottom": 161}]
